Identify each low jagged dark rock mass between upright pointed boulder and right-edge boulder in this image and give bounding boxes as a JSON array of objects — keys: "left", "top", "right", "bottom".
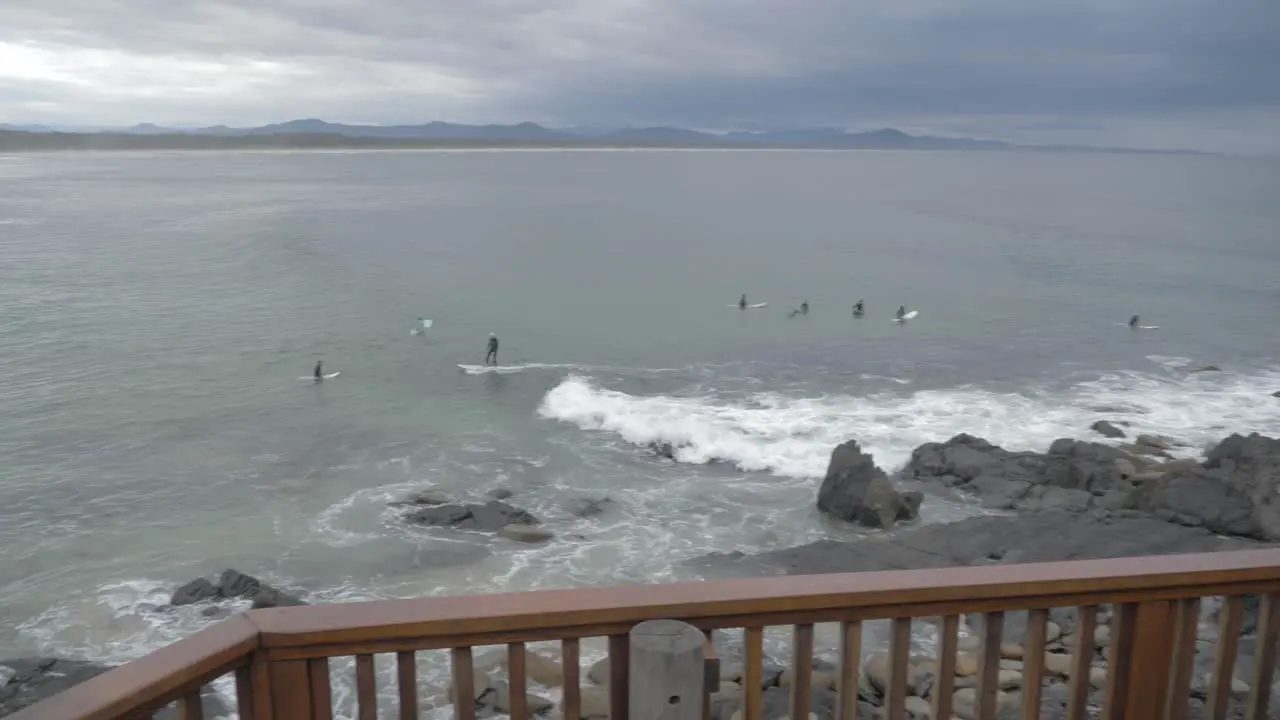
[{"left": 902, "top": 434, "right": 1134, "bottom": 510}]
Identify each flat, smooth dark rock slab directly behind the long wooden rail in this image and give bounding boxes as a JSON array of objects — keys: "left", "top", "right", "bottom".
[{"left": 687, "top": 510, "right": 1260, "bottom": 573}]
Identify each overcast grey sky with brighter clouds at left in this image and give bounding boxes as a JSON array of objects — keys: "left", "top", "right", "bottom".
[{"left": 0, "top": 0, "right": 1280, "bottom": 152}]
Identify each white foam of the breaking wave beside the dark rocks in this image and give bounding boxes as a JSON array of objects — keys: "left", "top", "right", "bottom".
[{"left": 539, "top": 359, "right": 1280, "bottom": 478}]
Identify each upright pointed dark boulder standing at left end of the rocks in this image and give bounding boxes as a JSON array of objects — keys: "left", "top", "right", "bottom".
[{"left": 818, "top": 441, "right": 923, "bottom": 528}]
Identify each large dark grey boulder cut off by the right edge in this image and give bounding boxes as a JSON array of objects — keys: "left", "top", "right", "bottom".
[{"left": 1140, "top": 433, "right": 1280, "bottom": 541}]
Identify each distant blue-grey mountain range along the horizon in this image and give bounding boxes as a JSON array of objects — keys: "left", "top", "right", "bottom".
[{"left": 0, "top": 119, "right": 1198, "bottom": 152}]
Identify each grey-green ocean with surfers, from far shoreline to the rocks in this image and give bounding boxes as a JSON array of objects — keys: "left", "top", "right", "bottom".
[{"left": 0, "top": 150, "right": 1280, "bottom": 707}]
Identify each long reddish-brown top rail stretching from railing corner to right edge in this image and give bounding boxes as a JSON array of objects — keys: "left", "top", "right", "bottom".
[{"left": 250, "top": 550, "right": 1280, "bottom": 648}]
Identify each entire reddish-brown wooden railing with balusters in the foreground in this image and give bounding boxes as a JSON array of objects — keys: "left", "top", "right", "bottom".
[{"left": 13, "top": 538, "right": 1280, "bottom": 720}]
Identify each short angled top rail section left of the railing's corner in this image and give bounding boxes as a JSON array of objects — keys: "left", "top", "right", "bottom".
[{"left": 9, "top": 615, "right": 259, "bottom": 720}]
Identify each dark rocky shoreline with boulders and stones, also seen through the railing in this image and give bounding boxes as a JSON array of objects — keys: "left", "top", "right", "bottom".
[{"left": 0, "top": 423, "right": 1280, "bottom": 720}]
